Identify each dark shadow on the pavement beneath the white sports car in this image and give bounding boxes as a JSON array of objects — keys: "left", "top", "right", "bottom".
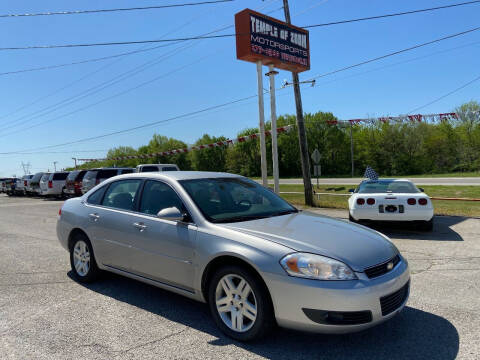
[{"left": 362, "top": 216, "right": 468, "bottom": 241}]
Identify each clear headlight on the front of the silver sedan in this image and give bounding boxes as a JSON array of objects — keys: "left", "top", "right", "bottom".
[{"left": 280, "top": 253, "right": 357, "bottom": 280}]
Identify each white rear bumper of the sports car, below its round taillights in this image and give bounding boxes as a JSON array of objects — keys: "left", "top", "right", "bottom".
[{"left": 350, "top": 206, "right": 433, "bottom": 221}]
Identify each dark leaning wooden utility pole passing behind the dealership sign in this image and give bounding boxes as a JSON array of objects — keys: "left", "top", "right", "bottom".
[{"left": 283, "top": 0, "right": 313, "bottom": 206}]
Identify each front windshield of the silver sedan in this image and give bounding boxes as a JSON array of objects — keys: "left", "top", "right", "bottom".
[{"left": 180, "top": 178, "right": 298, "bottom": 223}]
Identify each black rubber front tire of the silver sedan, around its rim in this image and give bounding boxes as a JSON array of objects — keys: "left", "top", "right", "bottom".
[{"left": 208, "top": 265, "right": 275, "bottom": 341}]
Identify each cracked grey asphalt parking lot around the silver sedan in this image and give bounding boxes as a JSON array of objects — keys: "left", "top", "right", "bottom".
[{"left": 0, "top": 194, "right": 480, "bottom": 360}]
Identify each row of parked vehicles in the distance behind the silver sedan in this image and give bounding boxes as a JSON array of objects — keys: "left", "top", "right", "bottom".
[{"left": 0, "top": 164, "right": 179, "bottom": 198}]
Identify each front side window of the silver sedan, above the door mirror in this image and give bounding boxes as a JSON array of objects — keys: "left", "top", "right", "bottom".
[{"left": 140, "top": 180, "right": 184, "bottom": 215}]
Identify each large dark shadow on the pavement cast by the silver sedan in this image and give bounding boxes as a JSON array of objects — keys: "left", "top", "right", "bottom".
[{"left": 68, "top": 272, "right": 459, "bottom": 360}]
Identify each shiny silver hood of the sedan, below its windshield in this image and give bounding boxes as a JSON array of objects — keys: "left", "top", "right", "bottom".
[{"left": 219, "top": 211, "right": 398, "bottom": 271}]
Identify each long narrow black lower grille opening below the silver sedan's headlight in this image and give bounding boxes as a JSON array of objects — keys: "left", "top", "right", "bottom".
[{"left": 302, "top": 308, "right": 372, "bottom": 325}]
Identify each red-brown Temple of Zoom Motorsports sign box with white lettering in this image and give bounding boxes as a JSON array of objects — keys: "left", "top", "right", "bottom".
[{"left": 235, "top": 9, "right": 310, "bottom": 72}]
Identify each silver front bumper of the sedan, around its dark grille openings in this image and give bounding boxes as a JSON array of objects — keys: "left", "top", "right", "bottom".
[{"left": 264, "top": 258, "right": 410, "bottom": 334}]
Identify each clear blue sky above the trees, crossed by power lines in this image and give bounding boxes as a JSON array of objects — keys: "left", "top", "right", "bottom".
[{"left": 0, "top": 0, "right": 480, "bottom": 176}]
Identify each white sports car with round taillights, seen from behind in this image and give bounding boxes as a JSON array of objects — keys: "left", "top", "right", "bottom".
[{"left": 348, "top": 179, "right": 433, "bottom": 230}]
